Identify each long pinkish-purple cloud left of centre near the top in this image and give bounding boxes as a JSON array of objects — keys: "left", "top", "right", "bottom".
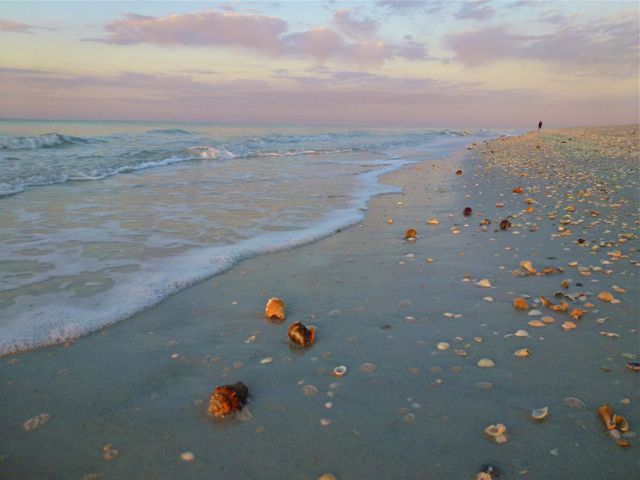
[{"left": 93, "top": 10, "right": 426, "bottom": 66}]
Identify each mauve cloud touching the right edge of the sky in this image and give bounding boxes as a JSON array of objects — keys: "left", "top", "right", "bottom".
[{"left": 445, "top": 18, "right": 639, "bottom": 75}]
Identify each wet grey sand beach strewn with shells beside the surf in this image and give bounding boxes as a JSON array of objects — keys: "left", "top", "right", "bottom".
[{"left": 0, "top": 126, "right": 640, "bottom": 480}]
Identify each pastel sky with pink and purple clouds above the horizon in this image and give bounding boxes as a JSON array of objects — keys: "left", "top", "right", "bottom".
[{"left": 0, "top": 0, "right": 640, "bottom": 128}]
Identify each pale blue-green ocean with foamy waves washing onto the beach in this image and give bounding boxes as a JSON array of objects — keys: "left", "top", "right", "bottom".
[{"left": 0, "top": 120, "right": 498, "bottom": 355}]
